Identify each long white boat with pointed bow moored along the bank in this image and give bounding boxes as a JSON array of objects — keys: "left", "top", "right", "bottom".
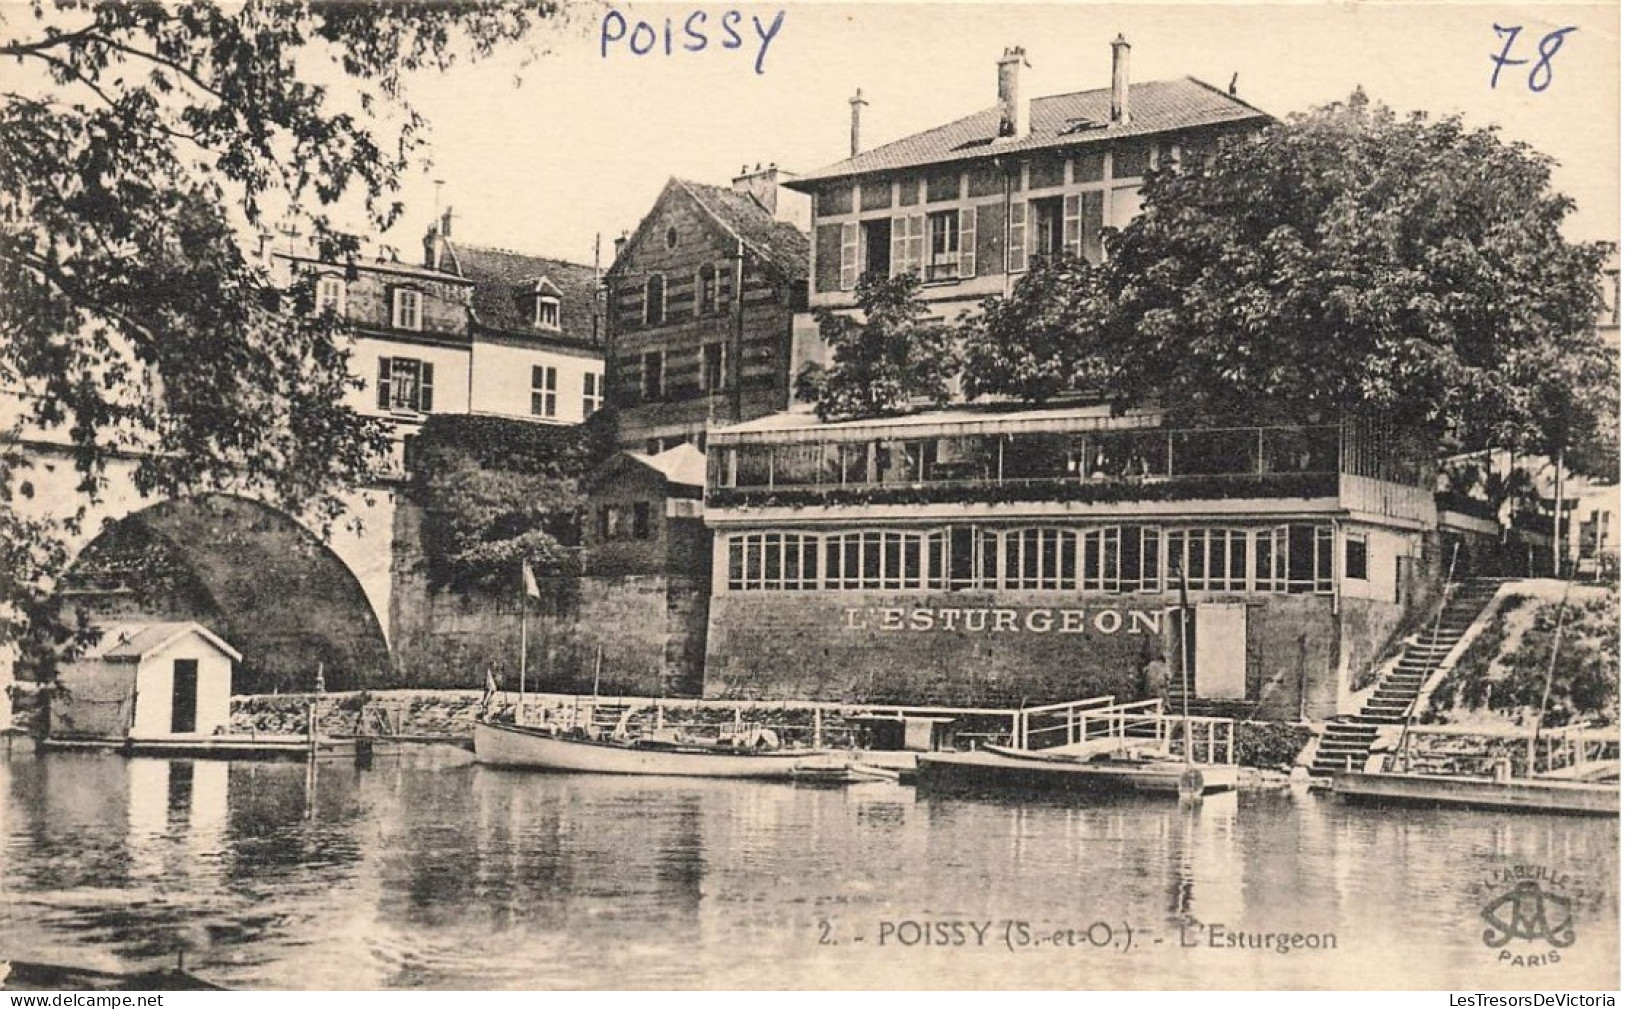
[{"left": 475, "top": 721, "right": 827, "bottom": 782}]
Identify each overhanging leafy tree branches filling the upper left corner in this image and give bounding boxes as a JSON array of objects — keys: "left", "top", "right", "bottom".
[{"left": 0, "top": 0, "right": 557, "bottom": 669}]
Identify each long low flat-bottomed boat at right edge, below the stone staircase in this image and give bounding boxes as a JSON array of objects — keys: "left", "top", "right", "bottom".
[{"left": 1331, "top": 772, "right": 1620, "bottom": 816}]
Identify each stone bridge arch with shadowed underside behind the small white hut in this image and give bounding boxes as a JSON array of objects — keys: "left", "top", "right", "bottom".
[{"left": 7, "top": 447, "right": 395, "bottom": 692}]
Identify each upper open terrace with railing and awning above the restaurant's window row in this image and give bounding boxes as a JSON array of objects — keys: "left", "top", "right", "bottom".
[{"left": 707, "top": 408, "right": 1432, "bottom": 513}]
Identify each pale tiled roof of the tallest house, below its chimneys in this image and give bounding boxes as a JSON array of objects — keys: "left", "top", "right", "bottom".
[{"left": 787, "top": 76, "right": 1271, "bottom": 188}]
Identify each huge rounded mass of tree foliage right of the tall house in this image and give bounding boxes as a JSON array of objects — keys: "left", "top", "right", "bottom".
[{"left": 978, "top": 93, "right": 1619, "bottom": 460}]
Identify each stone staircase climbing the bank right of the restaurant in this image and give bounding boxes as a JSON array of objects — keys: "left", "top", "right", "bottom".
[{"left": 1310, "top": 578, "right": 1502, "bottom": 775}]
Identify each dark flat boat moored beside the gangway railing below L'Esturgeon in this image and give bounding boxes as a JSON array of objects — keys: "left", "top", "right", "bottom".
[{"left": 918, "top": 751, "right": 1237, "bottom": 796}]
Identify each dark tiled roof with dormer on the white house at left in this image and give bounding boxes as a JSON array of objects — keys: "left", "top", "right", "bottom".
[{"left": 442, "top": 240, "right": 598, "bottom": 344}]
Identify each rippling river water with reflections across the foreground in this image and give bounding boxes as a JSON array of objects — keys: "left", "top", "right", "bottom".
[{"left": 0, "top": 751, "right": 1620, "bottom": 990}]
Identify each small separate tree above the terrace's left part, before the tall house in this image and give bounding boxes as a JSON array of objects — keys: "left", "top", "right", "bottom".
[{"left": 796, "top": 273, "right": 959, "bottom": 421}]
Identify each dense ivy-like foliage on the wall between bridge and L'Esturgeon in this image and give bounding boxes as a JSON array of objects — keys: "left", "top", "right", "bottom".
[{"left": 411, "top": 414, "right": 614, "bottom": 591}]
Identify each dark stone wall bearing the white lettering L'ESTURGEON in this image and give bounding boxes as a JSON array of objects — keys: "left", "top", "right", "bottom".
[{"left": 705, "top": 591, "right": 1339, "bottom": 718}]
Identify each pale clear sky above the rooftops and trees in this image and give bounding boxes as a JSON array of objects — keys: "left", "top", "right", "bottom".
[{"left": 385, "top": 0, "right": 1620, "bottom": 263}]
